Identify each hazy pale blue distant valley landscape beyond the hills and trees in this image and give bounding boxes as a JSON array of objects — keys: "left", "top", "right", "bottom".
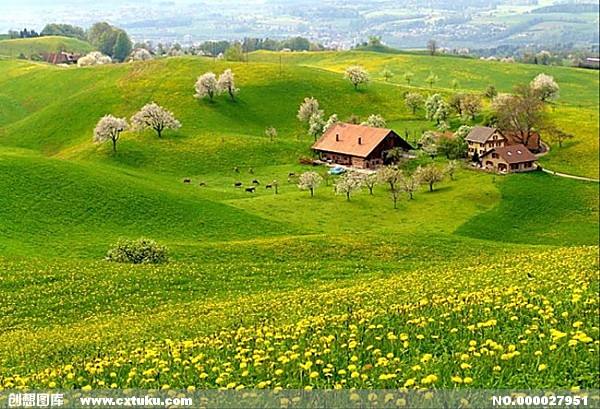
[{"left": 0, "top": 0, "right": 598, "bottom": 56}]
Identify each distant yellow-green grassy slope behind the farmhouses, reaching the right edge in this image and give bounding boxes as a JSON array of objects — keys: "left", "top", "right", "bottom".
[{"left": 250, "top": 51, "right": 599, "bottom": 178}]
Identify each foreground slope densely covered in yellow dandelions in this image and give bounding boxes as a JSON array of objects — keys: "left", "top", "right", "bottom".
[{"left": 0, "top": 247, "right": 600, "bottom": 391}]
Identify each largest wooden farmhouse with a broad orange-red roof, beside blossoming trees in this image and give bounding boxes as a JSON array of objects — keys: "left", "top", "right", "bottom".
[{"left": 312, "top": 123, "right": 413, "bottom": 169}]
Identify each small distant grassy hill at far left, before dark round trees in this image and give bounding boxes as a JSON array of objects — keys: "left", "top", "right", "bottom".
[{"left": 0, "top": 36, "right": 93, "bottom": 58}]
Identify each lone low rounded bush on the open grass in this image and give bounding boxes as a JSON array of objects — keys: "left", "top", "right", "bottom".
[{"left": 106, "top": 238, "right": 169, "bottom": 264}]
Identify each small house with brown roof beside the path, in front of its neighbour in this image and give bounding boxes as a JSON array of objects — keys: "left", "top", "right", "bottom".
[{"left": 481, "top": 144, "right": 537, "bottom": 173}]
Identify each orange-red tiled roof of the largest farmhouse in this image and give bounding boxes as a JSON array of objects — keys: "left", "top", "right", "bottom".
[{"left": 312, "top": 123, "right": 393, "bottom": 158}]
